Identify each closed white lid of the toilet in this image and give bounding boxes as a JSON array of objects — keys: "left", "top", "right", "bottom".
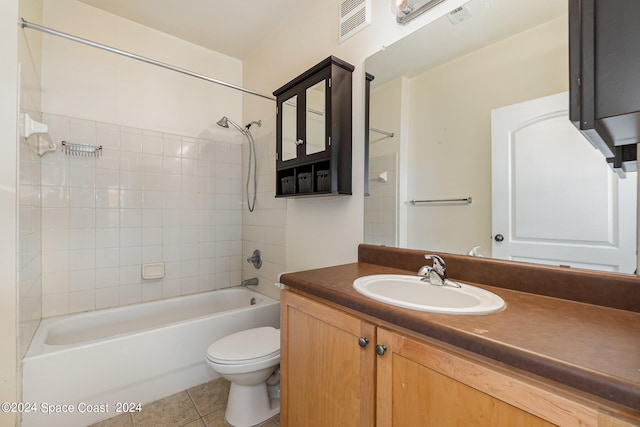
[{"left": 207, "top": 326, "right": 280, "bottom": 365}]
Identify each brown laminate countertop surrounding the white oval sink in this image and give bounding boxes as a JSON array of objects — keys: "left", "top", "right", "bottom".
[{"left": 281, "top": 257, "right": 640, "bottom": 410}]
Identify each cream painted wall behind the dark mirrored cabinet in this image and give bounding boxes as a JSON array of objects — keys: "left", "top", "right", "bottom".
[{"left": 243, "top": 0, "right": 470, "bottom": 280}]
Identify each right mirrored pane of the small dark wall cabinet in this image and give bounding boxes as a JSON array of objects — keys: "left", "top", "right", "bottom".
[{"left": 305, "top": 80, "right": 327, "bottom": 155}]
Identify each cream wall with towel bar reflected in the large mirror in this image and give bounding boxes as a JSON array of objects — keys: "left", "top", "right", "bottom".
[{"left": 407, "top": 16, "right": 569, "bottom": 256}]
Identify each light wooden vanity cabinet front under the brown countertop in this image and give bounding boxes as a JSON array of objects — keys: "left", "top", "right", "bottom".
[{"left": 280, "top": 290, "right": 640, "bottom": 427}]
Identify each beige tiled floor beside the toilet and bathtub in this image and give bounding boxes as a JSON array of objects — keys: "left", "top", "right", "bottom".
[{"left": 91, "top": 378, "right": 280, "bottom": 427}]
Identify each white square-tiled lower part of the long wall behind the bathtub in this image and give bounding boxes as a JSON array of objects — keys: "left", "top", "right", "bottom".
[{"left": 40, "top": 114, "right": 242, "bottom": 317}]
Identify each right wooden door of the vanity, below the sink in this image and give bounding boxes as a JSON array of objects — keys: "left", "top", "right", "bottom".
[{"left": 376, "top": 329, "right": 596, "bottom": 427}]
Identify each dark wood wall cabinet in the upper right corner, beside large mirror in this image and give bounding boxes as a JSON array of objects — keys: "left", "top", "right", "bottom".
[{"left": 569, "top": 0, "right": 640, "bottom": 174}]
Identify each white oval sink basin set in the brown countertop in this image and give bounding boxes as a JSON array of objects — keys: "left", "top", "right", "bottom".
[{"left": 353, "top": 274, "right": 505, "bottom": 314}]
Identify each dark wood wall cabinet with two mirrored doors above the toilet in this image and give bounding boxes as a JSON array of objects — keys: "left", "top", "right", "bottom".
[{"left": 273, "top": 56, "right": 354, "bottom": 197}]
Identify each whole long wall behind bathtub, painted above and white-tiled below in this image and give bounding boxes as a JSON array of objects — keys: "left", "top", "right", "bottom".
[{"left": 34, "top": 0, "right": 250, "bottom": 317}]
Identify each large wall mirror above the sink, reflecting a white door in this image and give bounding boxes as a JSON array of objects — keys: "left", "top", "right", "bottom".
[{"left": 364, "top": 0, "right": 637, "bottom": 273}]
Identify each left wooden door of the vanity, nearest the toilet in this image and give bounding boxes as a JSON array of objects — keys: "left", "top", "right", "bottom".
[{"left": 280, "top": 291, "right": 375, "bottom": 427}]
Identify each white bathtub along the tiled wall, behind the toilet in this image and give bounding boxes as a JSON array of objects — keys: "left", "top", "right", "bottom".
[{"left": 20, "top": 287, "right": 280, "bottom": 427}]
